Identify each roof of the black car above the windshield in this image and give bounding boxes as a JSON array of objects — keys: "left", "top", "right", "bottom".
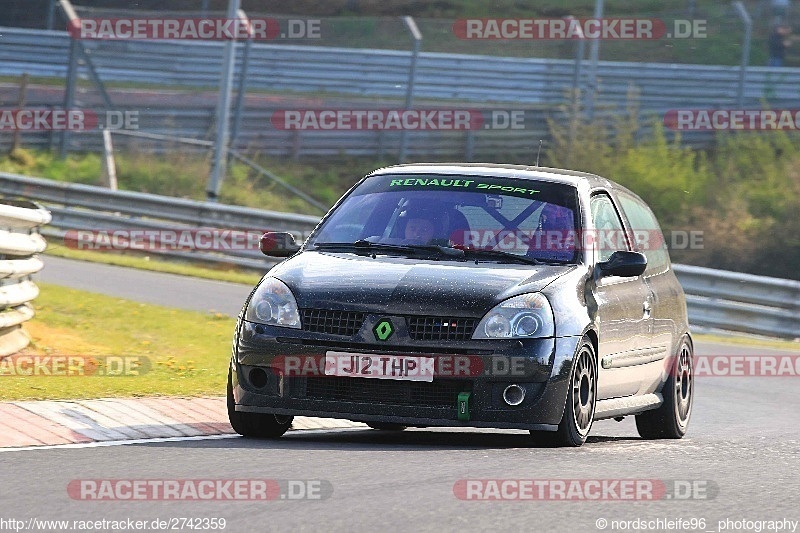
[{"left": 369, "top": 163, "right": 619, "bottom": 188}]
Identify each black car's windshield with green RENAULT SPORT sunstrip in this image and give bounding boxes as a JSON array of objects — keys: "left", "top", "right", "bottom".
[{"left": 308, "top": 174, "right": 580, "bottom": 262}]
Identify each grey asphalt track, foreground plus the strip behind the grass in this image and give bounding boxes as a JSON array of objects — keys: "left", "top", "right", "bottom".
[{"left": 0, "top": 257, "right": 800, "bottom": 532}]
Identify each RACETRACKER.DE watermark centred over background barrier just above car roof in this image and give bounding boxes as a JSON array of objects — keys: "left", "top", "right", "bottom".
[{"left": 270, "top": 108, "right": 525, "bottom": 131}]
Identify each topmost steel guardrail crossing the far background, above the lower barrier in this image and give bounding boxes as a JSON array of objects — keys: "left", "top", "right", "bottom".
[{"left": 0, "top": 28, "right": 800, "bottom": 109}]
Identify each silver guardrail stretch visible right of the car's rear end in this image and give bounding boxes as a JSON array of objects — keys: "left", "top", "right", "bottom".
[{"left": 675, "top": 265, "right": 800, "bottom": 339}]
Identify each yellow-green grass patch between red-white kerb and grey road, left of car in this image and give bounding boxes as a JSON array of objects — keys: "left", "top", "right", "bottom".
[{"left": 0, "top": 283, "right": 235, "bottom": 401}]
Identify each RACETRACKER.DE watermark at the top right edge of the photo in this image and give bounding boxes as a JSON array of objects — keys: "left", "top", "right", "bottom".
[{"left": 453, "top": 17, "right": 708, "bottom": 40}]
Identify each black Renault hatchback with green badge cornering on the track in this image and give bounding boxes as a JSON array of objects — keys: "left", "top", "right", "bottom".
[{"left": 227, "top": 164, "right": 694, "bottom": 446}]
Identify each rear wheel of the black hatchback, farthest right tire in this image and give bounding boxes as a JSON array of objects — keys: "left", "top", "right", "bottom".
[{"left": 636, "top": 337, "right": 694, "bottom": 439}]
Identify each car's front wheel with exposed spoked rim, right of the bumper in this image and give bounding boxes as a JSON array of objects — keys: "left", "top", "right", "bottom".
[{"left": 531, "top": 337, "right": 597, "bottom": 447}]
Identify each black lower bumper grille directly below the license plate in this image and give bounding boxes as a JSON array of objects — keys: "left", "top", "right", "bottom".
[{"left": 306, "top": 377, "right": 472, "bottom": 407}]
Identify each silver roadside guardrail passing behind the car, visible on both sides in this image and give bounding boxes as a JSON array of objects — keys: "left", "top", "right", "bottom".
[{"left": 0, "top": 173, "right": 800, "bottom": 338}]
